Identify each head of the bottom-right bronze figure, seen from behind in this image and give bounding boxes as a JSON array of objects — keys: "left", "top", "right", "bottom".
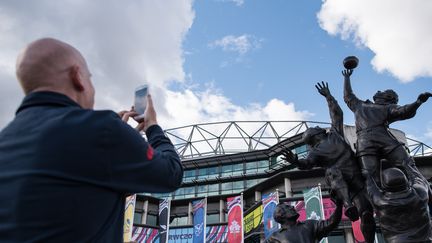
[{"left": 382, "top": 168, "right": 408, "bottom": 192}]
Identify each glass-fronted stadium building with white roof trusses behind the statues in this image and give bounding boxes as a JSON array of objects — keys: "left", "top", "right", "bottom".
[{"left": 128, "top": 121, "right": 432, "bottom": 243}]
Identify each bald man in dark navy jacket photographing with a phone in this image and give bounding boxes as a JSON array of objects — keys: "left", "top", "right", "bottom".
[{"left": 0, "top": 38, "right": 183, "bottom": 242}]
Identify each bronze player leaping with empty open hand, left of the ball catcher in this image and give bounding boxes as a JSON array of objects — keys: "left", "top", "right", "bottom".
[{"left": 283, "top": 82, "right": 375, "bottom": 243}]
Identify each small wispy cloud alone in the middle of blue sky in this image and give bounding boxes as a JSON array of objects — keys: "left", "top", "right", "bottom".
[{"left": 209, "top": 34, "right": 262, "bottom": 55}]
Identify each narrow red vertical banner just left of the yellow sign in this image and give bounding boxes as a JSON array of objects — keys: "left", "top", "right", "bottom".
[{"left": 227, "top": 196, "right": 244, "bottom": 243}]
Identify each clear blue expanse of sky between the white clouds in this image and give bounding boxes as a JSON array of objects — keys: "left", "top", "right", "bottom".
[{"left": 177, "top": 0, "right": 432, "bottom": 144}]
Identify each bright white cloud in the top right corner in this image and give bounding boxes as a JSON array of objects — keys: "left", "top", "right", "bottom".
[{"left": 317, "top": 0, "right": 432, "bottom": 82}]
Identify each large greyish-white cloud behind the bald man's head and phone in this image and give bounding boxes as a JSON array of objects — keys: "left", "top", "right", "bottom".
[{"left": 0, "top": 0, "right": 194, "bottom": 126}]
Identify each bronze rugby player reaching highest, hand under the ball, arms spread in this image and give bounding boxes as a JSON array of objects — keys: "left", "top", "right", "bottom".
[{"left": 342, "top": 69, "right": 432, "bottom": 181}]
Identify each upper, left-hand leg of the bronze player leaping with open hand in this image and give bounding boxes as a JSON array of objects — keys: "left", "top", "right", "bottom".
[{"left": 326, "top": 168, "right": 359, "bottom": 221}]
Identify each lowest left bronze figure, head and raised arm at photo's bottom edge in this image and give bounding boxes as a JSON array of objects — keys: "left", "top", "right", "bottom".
[{"left": 266, "top": 202, "right": 342, "bottom": 243}]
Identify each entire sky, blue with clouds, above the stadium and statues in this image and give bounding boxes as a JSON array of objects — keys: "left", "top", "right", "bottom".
[{"left": 0, "top": 0, "right": 432, "bottom": 144}]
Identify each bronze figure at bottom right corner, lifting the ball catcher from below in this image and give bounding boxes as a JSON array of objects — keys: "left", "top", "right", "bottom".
[{"left": 366, "top": 164, "right": 432, "bottom": 243}]
